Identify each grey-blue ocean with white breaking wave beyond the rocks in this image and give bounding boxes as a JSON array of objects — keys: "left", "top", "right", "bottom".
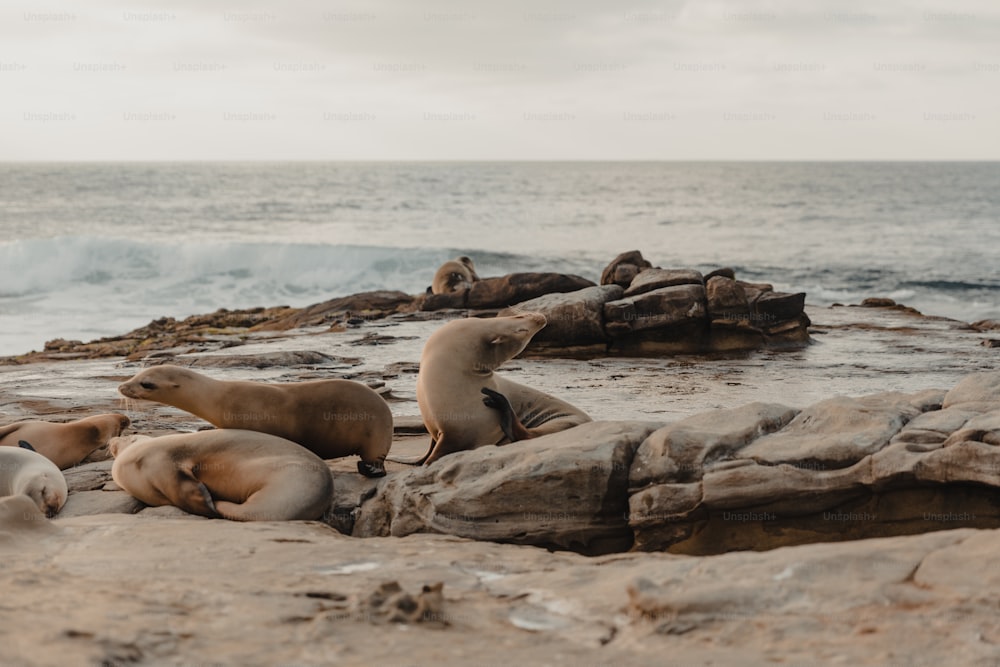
[{"left": 0, "top": 162, "right": 1000, "bottom": 355}]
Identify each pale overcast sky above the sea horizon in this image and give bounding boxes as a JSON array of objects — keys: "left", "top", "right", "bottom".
[{"left": 0, "top": 0, "right": 1000, "bottom": 160}]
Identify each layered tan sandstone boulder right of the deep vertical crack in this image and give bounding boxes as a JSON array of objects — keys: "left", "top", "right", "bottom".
[{"left": 629, "top": 373, "right": 1000, "bottom": 554}]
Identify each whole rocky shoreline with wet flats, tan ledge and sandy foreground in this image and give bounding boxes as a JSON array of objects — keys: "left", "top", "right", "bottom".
[{"left": 0, "top": 254, "right": 1000, "bottom": 666}]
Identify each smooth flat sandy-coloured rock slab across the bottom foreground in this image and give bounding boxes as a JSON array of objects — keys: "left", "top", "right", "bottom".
[{"left": 0, "top": 508, "right": 1000, "bottom": 667}]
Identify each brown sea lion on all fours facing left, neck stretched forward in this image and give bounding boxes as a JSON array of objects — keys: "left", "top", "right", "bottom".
[{"left": 118, "top": 365, "right": 392, "bottom": 477}]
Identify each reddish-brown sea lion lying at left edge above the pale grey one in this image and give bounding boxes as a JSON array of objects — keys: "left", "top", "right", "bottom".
[{"left": 0, "top": 412, "right": 131, "bottom": 470}]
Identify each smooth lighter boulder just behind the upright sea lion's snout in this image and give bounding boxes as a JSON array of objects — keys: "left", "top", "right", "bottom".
[{"left": 500, "top": 285, "right": 623, "bottom": 347}]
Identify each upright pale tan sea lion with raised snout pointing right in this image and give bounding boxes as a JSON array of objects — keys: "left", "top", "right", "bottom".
[{"left": 390, "top": 313, "right": 590, "bottom": 464}]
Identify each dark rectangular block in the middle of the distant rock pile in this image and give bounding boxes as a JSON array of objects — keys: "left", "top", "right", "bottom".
[{"left": 604, "top": 285, "right": 708, "bottom": 338}]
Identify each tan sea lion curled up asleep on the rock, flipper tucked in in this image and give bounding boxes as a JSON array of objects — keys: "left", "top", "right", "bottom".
[{"left": 109, "top": 429, "right": 333, "bottom": 521}]
